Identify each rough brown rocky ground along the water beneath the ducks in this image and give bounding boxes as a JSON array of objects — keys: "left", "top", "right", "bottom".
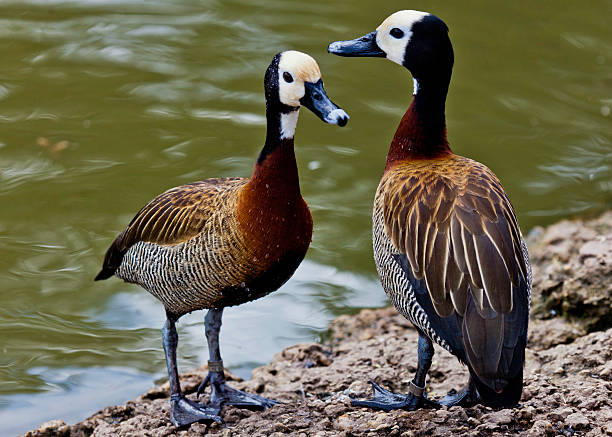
[{"left": 25, "top": 212, "right": 612, "bottom": 437}]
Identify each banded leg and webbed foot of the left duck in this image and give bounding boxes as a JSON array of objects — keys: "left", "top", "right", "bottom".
[{"left": 198, "top": 309, "right": 277, "bottom": 409}]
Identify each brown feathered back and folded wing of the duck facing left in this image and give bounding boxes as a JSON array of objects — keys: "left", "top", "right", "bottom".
[{"left": 384, "top": 159, "right": 528, "bottom": 379}]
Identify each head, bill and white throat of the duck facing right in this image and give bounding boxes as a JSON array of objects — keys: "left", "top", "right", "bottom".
[{"left": 264, "top": 50, "right": 349, "bottom": 138}]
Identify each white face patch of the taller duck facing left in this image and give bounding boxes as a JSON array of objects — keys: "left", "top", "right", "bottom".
[{"left": 376, "top": 10, "right": 430, "bottom": 65}]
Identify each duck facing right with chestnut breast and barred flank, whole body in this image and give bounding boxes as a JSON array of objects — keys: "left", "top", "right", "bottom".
[{"left": 95, "top": 50, "right": 349, "bottom": 426}]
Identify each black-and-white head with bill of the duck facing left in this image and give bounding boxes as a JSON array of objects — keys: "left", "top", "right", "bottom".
[{"left": 328, "top": 10, "right": 454, "bottom": 94}]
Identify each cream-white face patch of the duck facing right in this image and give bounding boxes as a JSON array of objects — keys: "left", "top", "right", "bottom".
[{"left": 278, "top": 50, "right": 321, "bottom": 107}]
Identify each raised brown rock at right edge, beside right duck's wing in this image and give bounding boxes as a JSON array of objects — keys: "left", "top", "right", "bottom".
[{"left": 528, "top": 211, "right": 612, "bottom": 332}]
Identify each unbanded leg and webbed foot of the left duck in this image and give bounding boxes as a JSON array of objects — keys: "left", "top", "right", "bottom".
[{"left": 162, "top": 315, "right": 222, "bottom": 426}]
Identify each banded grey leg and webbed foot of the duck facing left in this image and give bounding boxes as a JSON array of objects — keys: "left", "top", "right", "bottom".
[{"left": 351, "top": 333, "right": 439, "bottom": 411}]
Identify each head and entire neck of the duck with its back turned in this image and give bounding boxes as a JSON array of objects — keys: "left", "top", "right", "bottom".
[{"left": 328, "top": 10, "right": 454, "bottom": 165}]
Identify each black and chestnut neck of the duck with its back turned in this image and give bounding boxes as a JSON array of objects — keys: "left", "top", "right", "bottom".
[{"left": 385, "top": 73, "right": 452, "bottom": 171}]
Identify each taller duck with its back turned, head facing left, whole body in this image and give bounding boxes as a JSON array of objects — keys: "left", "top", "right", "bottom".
[{"left": 328, "top": 10, "right": 532, "bottom": 411}]
